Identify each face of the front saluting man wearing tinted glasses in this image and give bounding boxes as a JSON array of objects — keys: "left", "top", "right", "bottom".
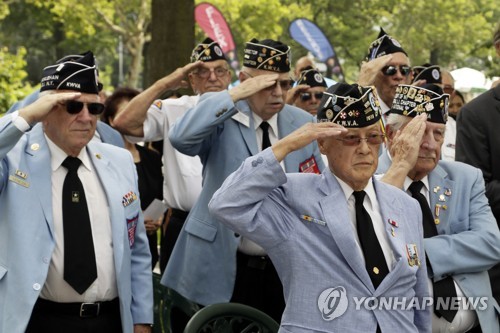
[{"left": 318, "top": 123, "right": 383, "bottom": 191}]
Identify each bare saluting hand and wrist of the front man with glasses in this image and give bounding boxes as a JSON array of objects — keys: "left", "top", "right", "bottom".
[{"left": 272, "top": 122, "right": 347, "bottom": 162}]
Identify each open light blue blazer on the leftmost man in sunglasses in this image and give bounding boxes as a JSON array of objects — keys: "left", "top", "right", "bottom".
[{"left": 0, "top": 115, "right": 153, "bottom": 333}]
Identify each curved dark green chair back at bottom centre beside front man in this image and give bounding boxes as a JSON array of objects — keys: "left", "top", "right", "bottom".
[{"left": 184, "top": 303, "right": 279, "bottom": 333}]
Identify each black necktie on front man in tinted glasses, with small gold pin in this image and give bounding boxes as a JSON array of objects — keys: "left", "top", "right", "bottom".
[{"left": 353, "top": 191, "right": 389, "bottom": 288}]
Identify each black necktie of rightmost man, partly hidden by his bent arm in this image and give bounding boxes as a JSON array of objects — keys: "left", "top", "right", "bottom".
[{"left": 408, "top": 181, "right": 457, "bottom": 323}]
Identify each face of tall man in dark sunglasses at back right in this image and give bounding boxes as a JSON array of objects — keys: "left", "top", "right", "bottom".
[{"left": 374, "top": 52, "right": 411, "bottom": 107}]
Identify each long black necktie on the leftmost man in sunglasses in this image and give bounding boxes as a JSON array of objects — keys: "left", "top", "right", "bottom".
[{"left": 62, "top": 156, "right": 97, "bottom": 294}]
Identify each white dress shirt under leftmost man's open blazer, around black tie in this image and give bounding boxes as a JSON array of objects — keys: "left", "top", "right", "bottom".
[{"left": 40, "top": 136, "right": 118, "bottom": 303}]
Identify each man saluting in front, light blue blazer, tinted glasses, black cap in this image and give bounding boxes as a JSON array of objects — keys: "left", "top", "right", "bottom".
[{"left": 209, "top": 83, "right": 430, "bottom": 333}]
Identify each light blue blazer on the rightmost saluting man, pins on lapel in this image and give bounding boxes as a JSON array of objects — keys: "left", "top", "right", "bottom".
[{"left": 377, "top": 151, "right": 500, "bottom": 333}]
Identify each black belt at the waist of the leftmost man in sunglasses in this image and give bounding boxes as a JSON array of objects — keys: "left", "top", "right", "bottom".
[{"left": 34, "top": 297, "right": 120, "bottom": 318}]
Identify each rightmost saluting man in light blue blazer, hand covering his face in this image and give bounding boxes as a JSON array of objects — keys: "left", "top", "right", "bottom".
[{"left": 377, "top": 84, "right": 500, "bottom": 333}]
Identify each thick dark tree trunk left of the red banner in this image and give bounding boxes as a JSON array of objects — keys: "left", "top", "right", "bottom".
[{"left": 144, "top": 0, "right": 195, "bottom": 94}]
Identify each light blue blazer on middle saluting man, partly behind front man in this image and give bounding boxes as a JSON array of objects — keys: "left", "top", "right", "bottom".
[{"left": 162, "top": 91, "right": 324, "bottom": 305}]
